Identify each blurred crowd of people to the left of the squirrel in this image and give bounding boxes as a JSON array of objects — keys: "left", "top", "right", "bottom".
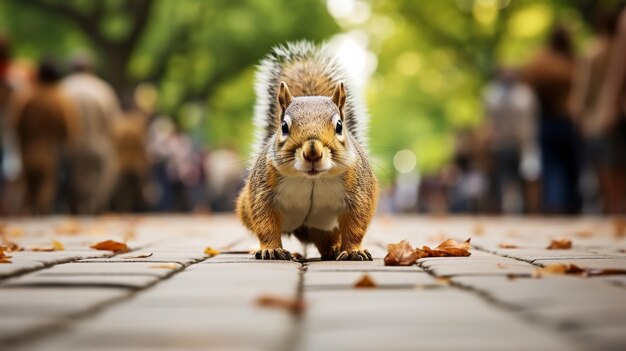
[{"left": 0, "top": 38, "right": 244, "bottom": 215}]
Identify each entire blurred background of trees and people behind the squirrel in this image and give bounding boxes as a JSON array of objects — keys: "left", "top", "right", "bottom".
[{"left": 0, "top": 0, "right": 626, "bottom": 215}]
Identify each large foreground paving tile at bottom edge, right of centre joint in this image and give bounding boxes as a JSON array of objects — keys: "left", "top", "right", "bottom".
[{"left": 301, "top": 289, "right": 575, "bottom": 350}]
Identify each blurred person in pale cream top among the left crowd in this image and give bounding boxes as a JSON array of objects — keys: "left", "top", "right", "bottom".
[{"left": 62, "top": 57, "right": 121, "bottom": 214}]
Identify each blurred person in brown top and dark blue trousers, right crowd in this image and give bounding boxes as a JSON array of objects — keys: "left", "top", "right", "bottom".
[{"left": 522, "top": 26, "right": 581, "bottom": 214}]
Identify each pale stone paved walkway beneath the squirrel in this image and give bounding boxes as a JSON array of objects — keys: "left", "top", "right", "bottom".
[{"left": 0, "top": 216, "right": 626, "bottom": 351}]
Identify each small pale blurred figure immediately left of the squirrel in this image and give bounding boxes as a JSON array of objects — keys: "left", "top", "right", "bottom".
[{"left": 204, "top": 147, "right": 246, "bottom": 212}]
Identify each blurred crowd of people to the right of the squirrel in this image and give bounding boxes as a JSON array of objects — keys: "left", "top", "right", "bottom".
[{"left": 410, "top": 10, "right": 626, "bottom": 214}]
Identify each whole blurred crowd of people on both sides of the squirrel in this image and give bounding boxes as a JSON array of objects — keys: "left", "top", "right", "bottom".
[{"left": 0, "top": 6, "right": 626, "bottom": 215}]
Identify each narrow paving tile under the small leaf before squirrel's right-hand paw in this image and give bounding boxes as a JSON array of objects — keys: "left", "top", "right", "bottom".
[{"left": 304, "top": 271, "right": 438, "bottom": 289}]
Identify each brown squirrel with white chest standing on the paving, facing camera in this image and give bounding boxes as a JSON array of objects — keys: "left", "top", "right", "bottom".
[{"left": 236, "top": 41, "right": 378, "bottom": 260}]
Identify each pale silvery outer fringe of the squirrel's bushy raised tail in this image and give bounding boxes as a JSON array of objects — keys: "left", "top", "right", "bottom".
[{"left": 252, "top": 41, "right": 369, "bottom": 152}]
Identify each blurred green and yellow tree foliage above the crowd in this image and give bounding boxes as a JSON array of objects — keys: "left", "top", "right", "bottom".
[{"left": 0, "top": 0, "right": 604, "bottom": 179}]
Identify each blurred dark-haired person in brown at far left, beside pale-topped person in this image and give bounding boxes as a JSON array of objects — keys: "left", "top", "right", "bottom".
[{"left": 11, "top": 60, "right": 80, "bottom": 214}]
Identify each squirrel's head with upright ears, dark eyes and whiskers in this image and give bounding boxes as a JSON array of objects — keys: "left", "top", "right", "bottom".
[{"left": 273, "top": 82, "right": 352, "bottom": 177}]
